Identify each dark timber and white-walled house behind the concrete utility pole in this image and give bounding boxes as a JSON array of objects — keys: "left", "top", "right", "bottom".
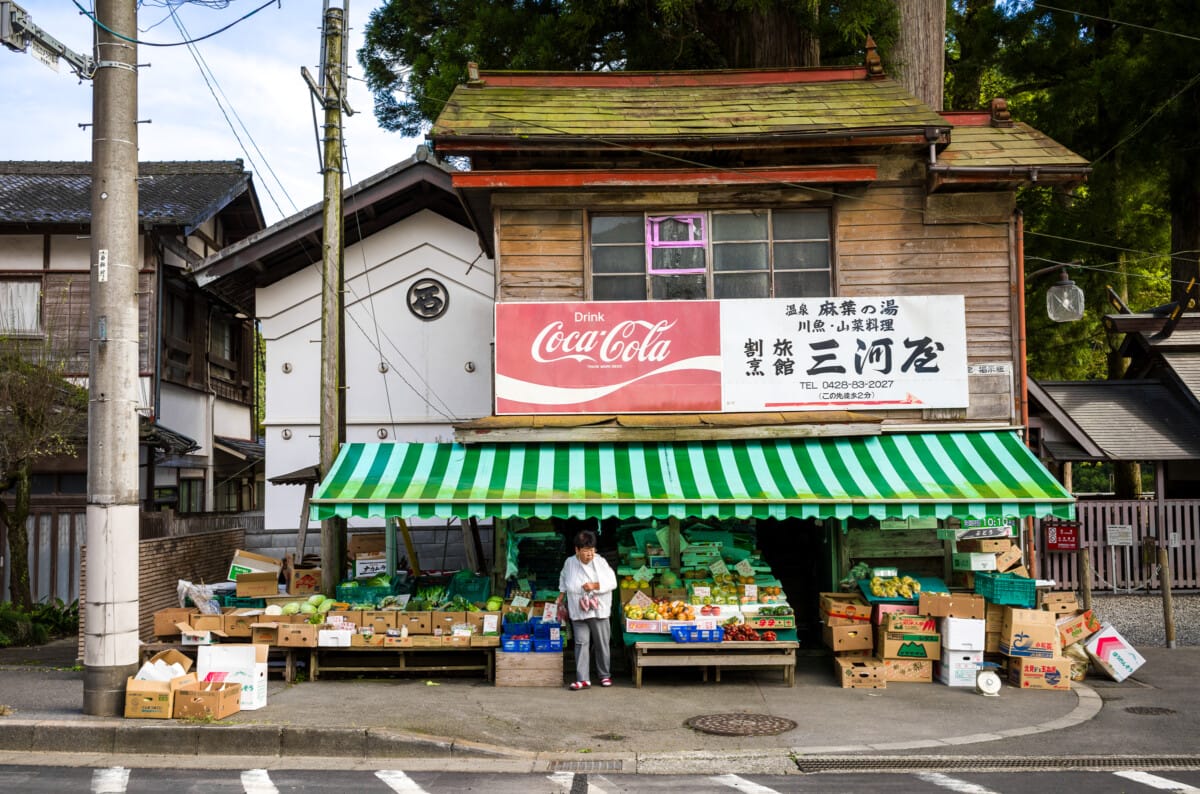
[{"left": 0, "top": 161, "right": 264, "bottom": 598}]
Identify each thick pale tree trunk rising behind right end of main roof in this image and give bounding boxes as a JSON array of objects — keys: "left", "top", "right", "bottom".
[{"left": 897, "top": 0, "right": 946, "bottom": 110}]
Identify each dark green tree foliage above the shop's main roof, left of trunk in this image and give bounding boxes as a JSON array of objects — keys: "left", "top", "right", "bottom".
[{"left": 358, "top": 0, "right": 898, "bottom": 136}]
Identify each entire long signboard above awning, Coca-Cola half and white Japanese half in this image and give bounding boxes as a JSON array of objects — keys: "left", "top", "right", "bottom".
[{"left": 496, "top": 295, "right": 968, "bottom": 414}]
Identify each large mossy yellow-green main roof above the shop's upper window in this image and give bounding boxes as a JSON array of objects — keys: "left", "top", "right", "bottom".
[{"left": 431, "top": 70, "right": 948, "bottom": 140}]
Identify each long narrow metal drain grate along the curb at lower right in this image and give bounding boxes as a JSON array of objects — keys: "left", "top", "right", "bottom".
[{"left": 794, "top": 756, "right": 1200, "bottom": 774}]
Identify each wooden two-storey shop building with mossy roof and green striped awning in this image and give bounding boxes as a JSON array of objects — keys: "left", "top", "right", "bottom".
[{"left": 312, "top": 57, "right": 1088, "bottom": 609}]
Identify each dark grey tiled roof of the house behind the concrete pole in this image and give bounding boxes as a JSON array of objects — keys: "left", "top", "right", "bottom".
[{"left": 0, "top": 160, "right": 250, "bottom": 227}]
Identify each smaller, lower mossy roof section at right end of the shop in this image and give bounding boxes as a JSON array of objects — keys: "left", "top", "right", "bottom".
[{"left": 937, "top": 115, "right": 1087, "bottom": 168}]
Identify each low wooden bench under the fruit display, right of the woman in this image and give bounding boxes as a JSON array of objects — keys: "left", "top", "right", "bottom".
[{"left": 626, "top": 634, "right": 800, "bottom": 688}]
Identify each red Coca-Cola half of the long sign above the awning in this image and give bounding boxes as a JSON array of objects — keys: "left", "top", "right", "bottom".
[{"left": 496, "top": 301, "right": 721, "bottom": 414}]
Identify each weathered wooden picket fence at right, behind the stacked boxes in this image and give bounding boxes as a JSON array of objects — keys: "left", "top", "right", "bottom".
[{"left": 1038, "top": 499, "right": 1200, "bottom": 593}]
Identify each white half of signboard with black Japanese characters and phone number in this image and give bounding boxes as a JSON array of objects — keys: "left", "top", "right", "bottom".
[{"left": 721, "top": 295, "right": 968, "bottom": 411}]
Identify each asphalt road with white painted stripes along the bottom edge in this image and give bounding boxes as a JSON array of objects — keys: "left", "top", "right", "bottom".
[{"left": 0, "top": 766, "right": 1200, "bottom": 794}]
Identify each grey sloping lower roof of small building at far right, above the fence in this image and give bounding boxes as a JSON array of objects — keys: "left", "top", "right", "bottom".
[{"left": 1040, "top": 380, "right": 1200, "bottom": 461}]
